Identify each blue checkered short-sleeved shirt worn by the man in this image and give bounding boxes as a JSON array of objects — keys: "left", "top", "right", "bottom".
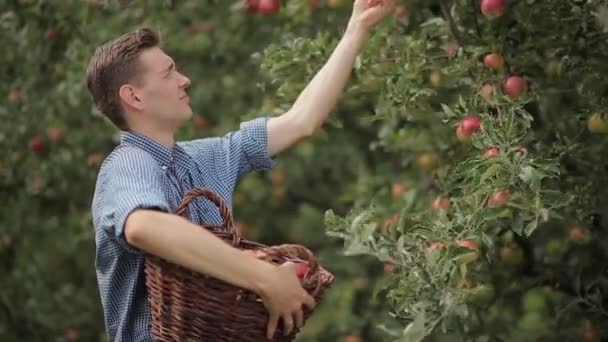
[{"left": 92, "top": 118, "right": 276, "bottom": 342}]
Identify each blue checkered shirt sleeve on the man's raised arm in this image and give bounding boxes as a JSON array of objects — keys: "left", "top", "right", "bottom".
[{"left": 179, "top": 117, "right": 276, "bottom": 185}]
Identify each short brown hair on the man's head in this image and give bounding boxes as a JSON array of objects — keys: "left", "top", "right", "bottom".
[{"left": 87, "top": 27, "right": 160, "bottom": 130}]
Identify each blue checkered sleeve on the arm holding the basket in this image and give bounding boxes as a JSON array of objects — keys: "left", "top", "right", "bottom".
[{"left": 93, "top": 150, "right": 170, "bottom": 254}]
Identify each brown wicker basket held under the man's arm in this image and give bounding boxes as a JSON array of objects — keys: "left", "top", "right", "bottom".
[{"left": 145, "top": 188, "right": 334, "bottom": 342}]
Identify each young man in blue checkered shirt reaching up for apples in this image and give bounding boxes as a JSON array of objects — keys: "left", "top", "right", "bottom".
[{"left": 87, "top": 0, "right": 393, "bottom": 342}]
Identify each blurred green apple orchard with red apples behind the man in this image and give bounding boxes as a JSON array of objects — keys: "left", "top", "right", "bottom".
[{"left": 0, "top": 0, "right": 608, "bottom": 342}]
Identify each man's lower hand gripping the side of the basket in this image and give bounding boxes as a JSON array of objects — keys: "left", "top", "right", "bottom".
[{"left": 260, "top": 262, "right": 315, "bottom": 339}]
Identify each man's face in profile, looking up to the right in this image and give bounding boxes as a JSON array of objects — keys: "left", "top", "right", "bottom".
[{"left": 137, "top": 47, "right": 192, "bottom": 128}]
